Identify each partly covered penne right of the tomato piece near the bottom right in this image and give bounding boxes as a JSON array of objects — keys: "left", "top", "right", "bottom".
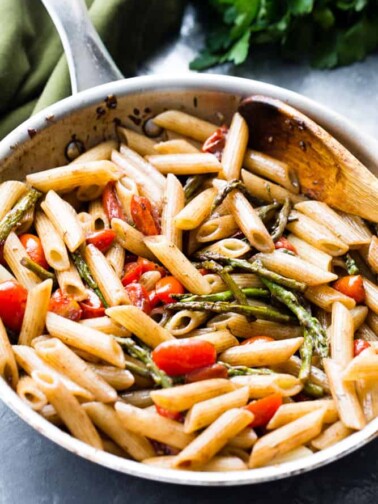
[{"left": 266, "top": 399, "right": 339, "bottom": 430}]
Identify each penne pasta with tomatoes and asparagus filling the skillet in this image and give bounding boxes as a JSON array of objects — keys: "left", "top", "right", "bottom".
[{"left": 0, "top": 102, "right": 378, "bottom": 471}]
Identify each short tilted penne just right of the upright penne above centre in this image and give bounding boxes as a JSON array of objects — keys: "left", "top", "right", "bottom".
[{"left": 173, "top": 187, "right": 217, "bottom": 231}]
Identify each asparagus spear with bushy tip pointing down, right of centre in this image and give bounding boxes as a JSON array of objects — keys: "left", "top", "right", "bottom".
[{"left": 261, "top": 278, "right": 328, "bottom": 357}]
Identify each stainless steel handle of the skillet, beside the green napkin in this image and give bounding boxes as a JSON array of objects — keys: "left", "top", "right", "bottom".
[{"left": 41, "top": 0, "right": 124, "bottom": 94}]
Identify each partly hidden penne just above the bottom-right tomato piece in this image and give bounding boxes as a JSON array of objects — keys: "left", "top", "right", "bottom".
[{"left": 231, "top": 374, "right": 303, "bottom": 399}]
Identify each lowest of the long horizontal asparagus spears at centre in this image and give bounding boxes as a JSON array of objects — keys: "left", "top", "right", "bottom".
[{"left": 166, "top": 301, "right": 293, "bottom": 322}]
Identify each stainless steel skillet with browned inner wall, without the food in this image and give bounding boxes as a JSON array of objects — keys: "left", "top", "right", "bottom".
[{"left": 0, "top": 0, "right": 378, "bottom": 486}]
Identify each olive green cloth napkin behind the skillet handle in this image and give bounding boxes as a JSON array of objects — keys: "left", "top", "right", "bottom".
[{"left": 0, "top": 0, "right": 185, "bottom": 138}]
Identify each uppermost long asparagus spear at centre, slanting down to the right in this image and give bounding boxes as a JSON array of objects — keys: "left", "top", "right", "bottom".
[{"left": 196, "top": 252, "right": 307, "bottom": 292}]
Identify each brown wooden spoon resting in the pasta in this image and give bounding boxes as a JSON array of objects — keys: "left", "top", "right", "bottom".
[{"left": 239, "top": 95, "right": 378, "bottom": 222}]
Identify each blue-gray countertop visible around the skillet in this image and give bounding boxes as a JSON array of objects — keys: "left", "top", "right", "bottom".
[{"left": 0, "top": 3, "right": 378, "bottom": 504}]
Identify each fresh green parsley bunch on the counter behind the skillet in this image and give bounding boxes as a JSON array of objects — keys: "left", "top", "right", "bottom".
[{"left": 190, "top": 0, "right": 378, "bottom": 70}]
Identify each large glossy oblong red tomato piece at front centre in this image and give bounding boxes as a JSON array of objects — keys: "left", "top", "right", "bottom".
[{"left": 152, "top": 339, "right": 217, "bottom": 376}]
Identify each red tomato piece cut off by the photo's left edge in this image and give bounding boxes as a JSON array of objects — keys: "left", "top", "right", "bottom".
[{"left": 0, "top": 280, "right": 28, "bottom": 332}]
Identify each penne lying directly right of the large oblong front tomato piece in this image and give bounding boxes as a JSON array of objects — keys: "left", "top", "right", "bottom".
[{"left": 219, "top": 338, "right": 303, "bottom": 367}]
